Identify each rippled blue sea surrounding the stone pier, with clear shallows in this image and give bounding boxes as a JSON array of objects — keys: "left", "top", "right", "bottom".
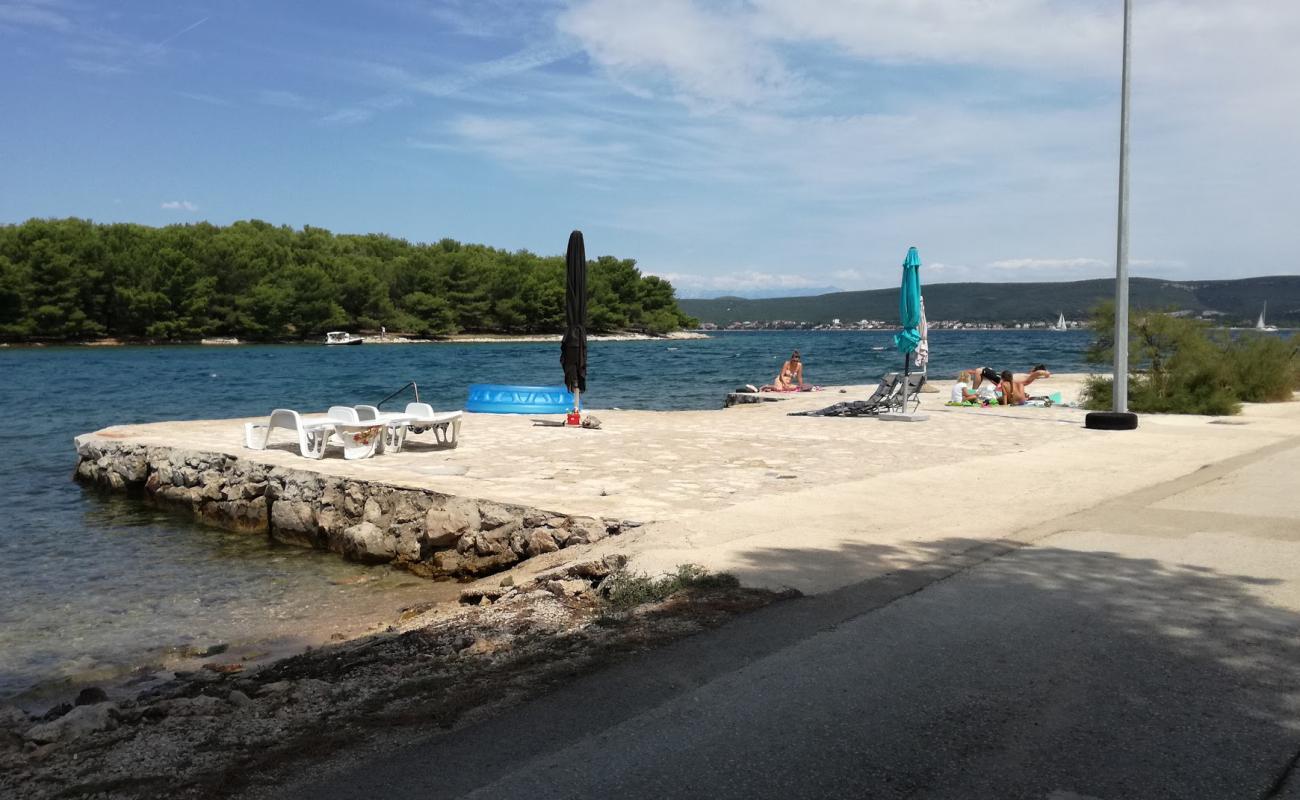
[{"left": 0, "top": 330, "right": 1088, "bottom": 699}]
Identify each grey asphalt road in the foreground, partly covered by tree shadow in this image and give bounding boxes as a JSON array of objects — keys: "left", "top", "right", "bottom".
[{"left": 291, "top": 442, "right": 1300, "bottom": 800}]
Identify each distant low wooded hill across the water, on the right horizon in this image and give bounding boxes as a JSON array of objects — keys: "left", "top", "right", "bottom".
[{"left": 677, "top": 274, "right": 1300, "bottom": 327}]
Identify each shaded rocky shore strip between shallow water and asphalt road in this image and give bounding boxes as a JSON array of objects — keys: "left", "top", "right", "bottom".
[{"left": 0, "top": 557, "right": 783, "bottom": 799}]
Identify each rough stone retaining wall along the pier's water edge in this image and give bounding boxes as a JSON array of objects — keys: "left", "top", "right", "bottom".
[{"left": 75, "top": 433, "right": 637, "bottom": 580}]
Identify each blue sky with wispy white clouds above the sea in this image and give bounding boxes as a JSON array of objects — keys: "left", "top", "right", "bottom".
[{"left": 0, "top": 0, "right": 1300, "bottom": 297}]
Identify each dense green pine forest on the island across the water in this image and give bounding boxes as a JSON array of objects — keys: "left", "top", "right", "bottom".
[{"left": 0, "top": 219, "right": 694, "bottom": 341}]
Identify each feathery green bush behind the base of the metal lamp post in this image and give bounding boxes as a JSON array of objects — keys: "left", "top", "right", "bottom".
[{"left": 1082, "top": 304, "right": 1300, "bottom": 416}]
